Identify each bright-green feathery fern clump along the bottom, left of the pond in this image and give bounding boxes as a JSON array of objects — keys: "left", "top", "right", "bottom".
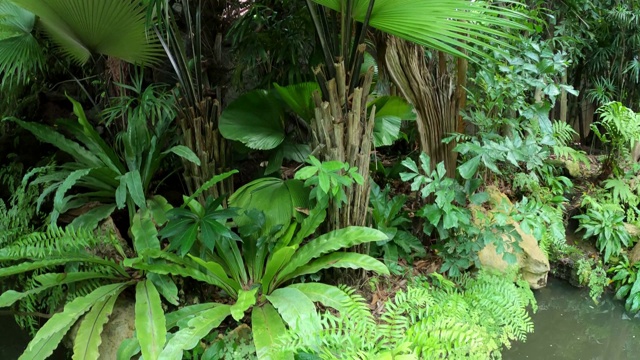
[{"left": 277, "top": 270, "right": 537, "bottom": 359}]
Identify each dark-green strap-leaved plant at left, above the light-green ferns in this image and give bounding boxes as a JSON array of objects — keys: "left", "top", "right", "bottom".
[{"left": 7, "top": 98, "right": 199, "bottom": 228}]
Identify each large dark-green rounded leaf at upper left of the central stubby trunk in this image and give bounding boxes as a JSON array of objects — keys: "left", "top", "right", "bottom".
[{"left": 218, "top": 90, "right": 285, "bottom": 150}]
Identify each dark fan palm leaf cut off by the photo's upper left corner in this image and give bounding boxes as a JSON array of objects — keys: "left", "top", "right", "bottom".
[{"left": 0, "top": 0, "right": 44, "bottom": 87}]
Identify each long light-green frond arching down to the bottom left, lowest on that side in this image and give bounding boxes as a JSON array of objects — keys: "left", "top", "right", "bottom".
[{"left": 19, "top": 283, "right": 129, "bottom": 360}]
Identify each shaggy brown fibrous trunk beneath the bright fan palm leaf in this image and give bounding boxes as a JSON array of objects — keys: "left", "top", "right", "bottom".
[{"left": 384, "top": 36, "right": 466, "bottom": 177}]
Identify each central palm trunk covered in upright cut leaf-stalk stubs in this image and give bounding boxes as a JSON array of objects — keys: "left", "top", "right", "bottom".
[{"left": 311, "top": 62, "right": 375, "bottom": 231}]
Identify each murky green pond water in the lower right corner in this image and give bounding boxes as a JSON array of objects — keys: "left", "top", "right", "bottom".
[{"left": 503, "top": 278, "right": 640, "bottom": 360}]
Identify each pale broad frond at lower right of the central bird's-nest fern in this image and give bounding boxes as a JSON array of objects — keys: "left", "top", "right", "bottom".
[{"left": 267, "top": 287, "right": 322, "bottom": 334}]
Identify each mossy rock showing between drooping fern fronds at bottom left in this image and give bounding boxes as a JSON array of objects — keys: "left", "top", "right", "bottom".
[{"left": 65, "top": 298, "right": 136, "bottom": 360}]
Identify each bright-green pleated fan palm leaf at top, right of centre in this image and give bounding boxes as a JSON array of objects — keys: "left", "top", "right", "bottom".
[{"left": 312, "top": 0, "right": 528, "bottom": 57}]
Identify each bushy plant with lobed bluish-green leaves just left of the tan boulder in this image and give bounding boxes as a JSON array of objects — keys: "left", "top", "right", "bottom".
[{"left": 400, "top": 153, "right": 520, "bottom": 276}]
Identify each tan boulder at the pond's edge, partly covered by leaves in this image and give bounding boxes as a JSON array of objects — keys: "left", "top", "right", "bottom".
[{"left": 478, "top": 187, "right": 551, "bottom": 289}]
